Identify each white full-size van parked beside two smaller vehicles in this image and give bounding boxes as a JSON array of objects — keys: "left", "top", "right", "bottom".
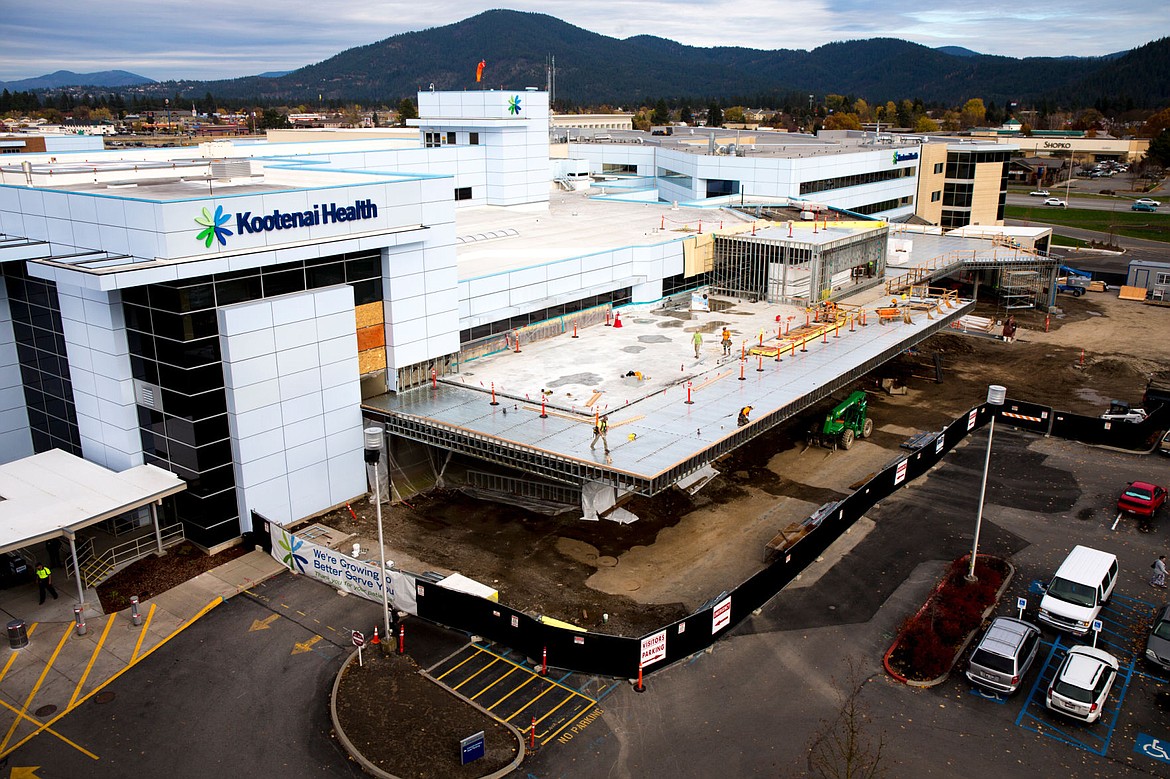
[{"left": 1039, "top": 546, "right": 1117, "bottom": 635}]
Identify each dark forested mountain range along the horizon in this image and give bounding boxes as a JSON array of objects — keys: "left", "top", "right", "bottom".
[{"left": 4, "top": 11, "right": 1170, "bottom": 109}]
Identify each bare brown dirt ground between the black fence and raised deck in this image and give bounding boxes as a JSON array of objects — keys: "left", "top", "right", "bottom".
[{"left": 318, "top": 290, "right": 1170, "bottom": 636}]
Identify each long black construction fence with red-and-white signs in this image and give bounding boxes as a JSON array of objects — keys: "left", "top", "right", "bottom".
[{"left": 287, "top": 399, "right": 1170, "bottom": 678}]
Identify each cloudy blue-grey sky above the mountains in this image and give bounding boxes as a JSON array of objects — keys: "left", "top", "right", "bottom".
[{"left": 0, "top": 0, "right": 1170, "bottom": 81}]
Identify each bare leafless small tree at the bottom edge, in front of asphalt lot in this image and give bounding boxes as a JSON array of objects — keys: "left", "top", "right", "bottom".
[{"left": 808, "top": 659, "right": 887, "bottom": 779}]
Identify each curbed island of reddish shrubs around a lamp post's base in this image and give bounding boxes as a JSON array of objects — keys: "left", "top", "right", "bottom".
[{"left": 887, "top": 554, "right": 1010, "bottom": 682}]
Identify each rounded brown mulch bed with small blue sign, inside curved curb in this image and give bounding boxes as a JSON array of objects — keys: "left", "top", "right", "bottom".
[{"left": 337, "top": 647, "right": 519, "bottom": 779}]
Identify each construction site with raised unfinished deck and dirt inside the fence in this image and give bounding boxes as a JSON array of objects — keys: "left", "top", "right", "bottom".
[{"left": 299, "top": 205, "right": 1156, "bottom": 635}]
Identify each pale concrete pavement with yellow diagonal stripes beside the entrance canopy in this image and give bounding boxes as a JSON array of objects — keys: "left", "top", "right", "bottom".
[{"left": 0, "top": 550, "right": 285, "bottom": 759}]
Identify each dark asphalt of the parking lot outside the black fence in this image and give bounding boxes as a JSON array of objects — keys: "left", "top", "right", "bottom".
[{"left": 9, "top": 425, "right": 1170, "bottom": 779}]
